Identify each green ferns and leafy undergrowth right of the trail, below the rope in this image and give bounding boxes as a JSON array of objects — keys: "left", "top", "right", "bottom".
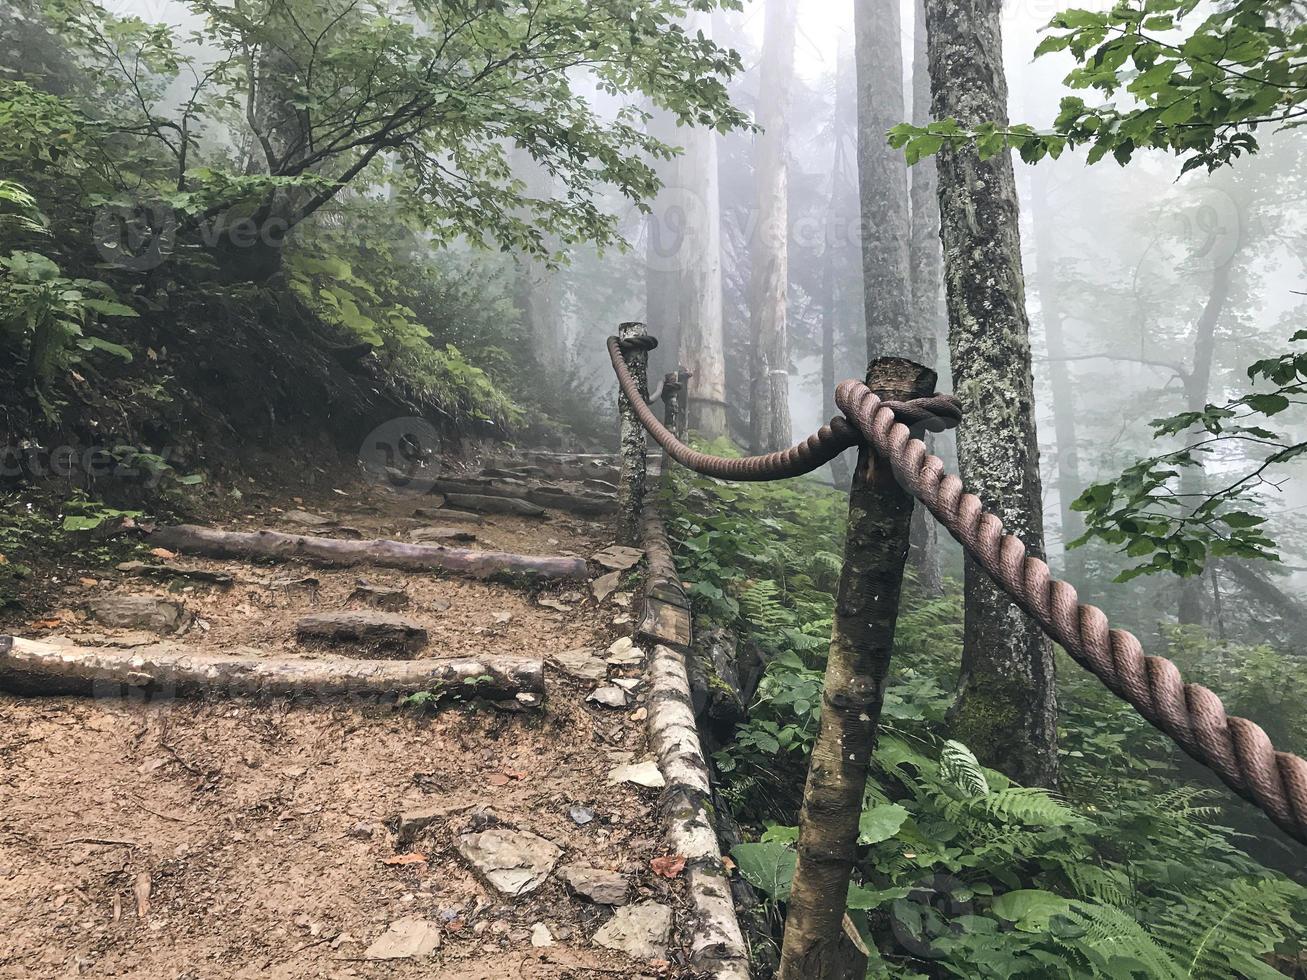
[{"left": 665, "top": 462, "right": 1307, "bottom": 980}]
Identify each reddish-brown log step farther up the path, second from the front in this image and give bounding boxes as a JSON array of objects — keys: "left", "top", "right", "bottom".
[{"left": 150, "top": 524, "right": 587, "bottom": 581}]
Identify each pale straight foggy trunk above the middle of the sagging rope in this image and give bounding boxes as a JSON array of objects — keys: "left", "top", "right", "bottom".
[{"left": 749, "top": 0, "right": 795, "bottom": 453}]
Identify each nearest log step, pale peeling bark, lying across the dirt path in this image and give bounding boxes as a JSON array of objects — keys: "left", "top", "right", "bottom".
[{"left": 0, "top": 636, "right": 545, "bottom": 707}]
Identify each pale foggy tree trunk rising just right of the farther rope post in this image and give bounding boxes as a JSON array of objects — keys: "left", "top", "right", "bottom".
[{"left": 676, "top": 12, "right": 727, "bottom": 439}]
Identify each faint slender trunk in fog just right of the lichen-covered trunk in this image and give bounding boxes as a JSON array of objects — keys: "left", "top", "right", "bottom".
[{"left": 1030, "top": 165, "right": 1087, "bottom": 595}]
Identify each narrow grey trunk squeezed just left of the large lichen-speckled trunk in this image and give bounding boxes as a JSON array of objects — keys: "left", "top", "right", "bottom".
[{"left": 908, "top": 0, "right": 944, "bottom": 596}]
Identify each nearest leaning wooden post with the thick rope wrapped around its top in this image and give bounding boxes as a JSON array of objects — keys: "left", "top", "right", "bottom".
[{"left": 779, "top": 358, "right": 936, "bottom": 980}]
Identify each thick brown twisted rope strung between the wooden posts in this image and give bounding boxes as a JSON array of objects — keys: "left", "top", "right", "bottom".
[{"left": 608, "top": 337, "right": 1307, "bottom": 844}]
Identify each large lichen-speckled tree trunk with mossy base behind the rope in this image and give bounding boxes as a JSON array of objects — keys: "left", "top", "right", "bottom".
[{"left": 925, "top": 0, "right": 1057, "bottom": 785}]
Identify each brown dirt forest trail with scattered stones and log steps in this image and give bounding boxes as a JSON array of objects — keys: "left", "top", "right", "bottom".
[{"left": 0, "top": 462, "right": 686, "bottom": 980}]
